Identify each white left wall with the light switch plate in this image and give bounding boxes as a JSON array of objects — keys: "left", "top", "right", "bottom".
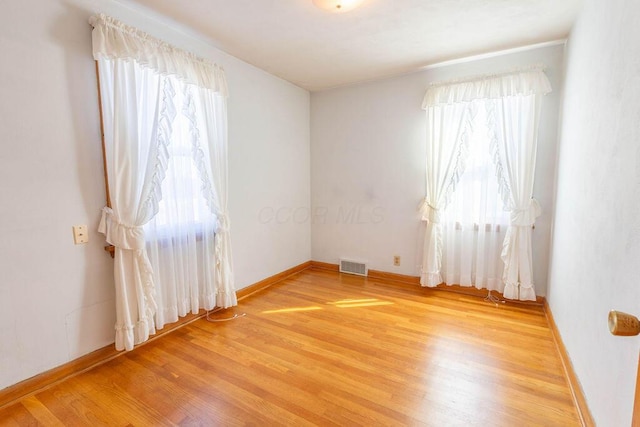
[{"left": 0, "top": 0, "right": 310, "bottom": 389}]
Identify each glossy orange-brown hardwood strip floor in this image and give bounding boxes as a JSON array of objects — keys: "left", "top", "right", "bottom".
[{"left": 0, "top": 270, "right": 580, "bottom": 426}]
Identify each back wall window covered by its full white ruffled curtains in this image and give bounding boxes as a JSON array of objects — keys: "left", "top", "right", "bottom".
[{"left": 420, "top": 66, "right": 551, "bottom": 301}]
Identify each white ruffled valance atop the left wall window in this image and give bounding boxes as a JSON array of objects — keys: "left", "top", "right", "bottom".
[{"left": 89, "top": 14, "right": 228, "bottom": 97}]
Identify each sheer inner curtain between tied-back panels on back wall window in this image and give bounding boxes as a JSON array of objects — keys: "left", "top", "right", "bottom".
[{"left": 442, "top": 101, "right": 509, "bottom": 292}]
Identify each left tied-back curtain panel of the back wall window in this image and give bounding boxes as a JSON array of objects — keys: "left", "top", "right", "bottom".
[{"left": 420, "top": 103, "right": 473, "bottom": 286}]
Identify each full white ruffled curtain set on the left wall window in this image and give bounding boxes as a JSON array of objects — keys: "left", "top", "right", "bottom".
[{"left": 91, "top": 15, "right": 237, "bottom": 350}]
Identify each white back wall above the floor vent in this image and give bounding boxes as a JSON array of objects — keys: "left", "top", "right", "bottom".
[{"left": 311, "top": 45, "right": 564, "bottom": 295}]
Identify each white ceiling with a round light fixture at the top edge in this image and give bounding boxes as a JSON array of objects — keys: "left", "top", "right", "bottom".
[{"left": 127, "top": 0, "right": 582, "bottom": 91}]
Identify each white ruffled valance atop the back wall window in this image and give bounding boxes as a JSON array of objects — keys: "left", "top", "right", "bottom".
[{"left": 422, "top": 67, "right": 551, "bottom": 109}]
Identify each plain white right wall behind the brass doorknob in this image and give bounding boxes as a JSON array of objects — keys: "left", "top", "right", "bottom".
[{"left": 548, "top": 0, "right": 640, "bottom": 427}]
